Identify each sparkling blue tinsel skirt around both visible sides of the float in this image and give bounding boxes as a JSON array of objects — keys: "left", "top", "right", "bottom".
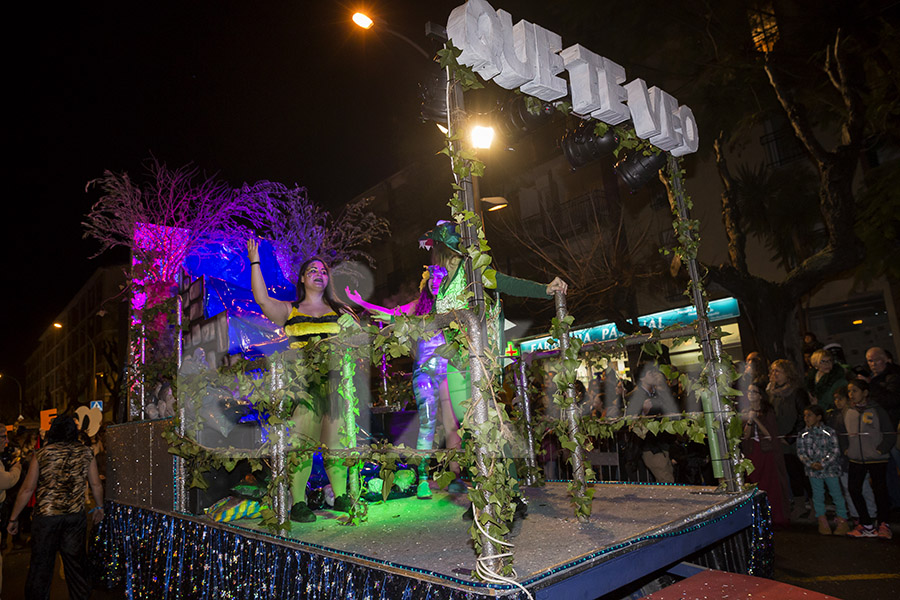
[{"left": 91, "top": 492, "right": 774, "bottom": 600}]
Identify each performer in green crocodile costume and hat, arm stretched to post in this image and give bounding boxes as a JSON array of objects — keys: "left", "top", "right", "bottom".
[{"left": 419, "top": 221, "right": 568, "bottom": 515}]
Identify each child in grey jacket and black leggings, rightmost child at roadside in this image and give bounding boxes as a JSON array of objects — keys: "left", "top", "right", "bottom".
[{"left": 844, "top": 379, "right": 897, "bottom": 540}]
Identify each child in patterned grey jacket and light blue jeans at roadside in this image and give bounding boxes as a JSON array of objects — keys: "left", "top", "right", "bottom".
[{"left": 797, "top": 404, "right": 850, "bottom": 535}]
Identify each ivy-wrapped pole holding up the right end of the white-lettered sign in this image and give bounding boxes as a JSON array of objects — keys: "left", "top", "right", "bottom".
[{"left": 668, "top": 155, "right": 740, "bottom": 492}]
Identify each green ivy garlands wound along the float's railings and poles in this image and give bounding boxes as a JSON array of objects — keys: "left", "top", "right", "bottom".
[{"left": 164, "top": 37, "right": 752, "bottom": 574}]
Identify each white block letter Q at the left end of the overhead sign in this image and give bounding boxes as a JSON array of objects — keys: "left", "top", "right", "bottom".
[{"left": 447, "top": 0, "right": 503, "bottom": 79}]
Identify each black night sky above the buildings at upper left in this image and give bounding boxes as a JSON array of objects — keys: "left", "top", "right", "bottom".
[{"left": 0, "top": 0, "right": 510, "bottom": 401}]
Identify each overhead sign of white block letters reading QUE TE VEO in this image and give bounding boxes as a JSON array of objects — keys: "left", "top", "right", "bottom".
[{"left": 447, "top": 0, "right": 699, "bottom": 156}]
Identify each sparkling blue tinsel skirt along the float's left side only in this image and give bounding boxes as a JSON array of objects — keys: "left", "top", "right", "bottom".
[{"left": 91, "top": 502, "right": 525, "bottom": 600}]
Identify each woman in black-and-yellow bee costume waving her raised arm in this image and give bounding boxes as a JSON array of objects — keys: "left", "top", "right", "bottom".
[{"left": 247, "top": 239, "right": 356, "bottom": 523}]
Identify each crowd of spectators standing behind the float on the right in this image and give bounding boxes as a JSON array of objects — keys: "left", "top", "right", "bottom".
[{"left": 542, "top": 336, "right": 900, "bottom": 539}]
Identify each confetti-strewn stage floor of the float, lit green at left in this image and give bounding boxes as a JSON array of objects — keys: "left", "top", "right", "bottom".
[{"left": 235, "top": 482, "right": 753, "bottom": 598}]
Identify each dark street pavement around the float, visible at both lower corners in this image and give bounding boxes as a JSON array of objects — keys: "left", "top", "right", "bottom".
[{"left": 2, "top": 510, "right": 900, "bottom": 600}]
